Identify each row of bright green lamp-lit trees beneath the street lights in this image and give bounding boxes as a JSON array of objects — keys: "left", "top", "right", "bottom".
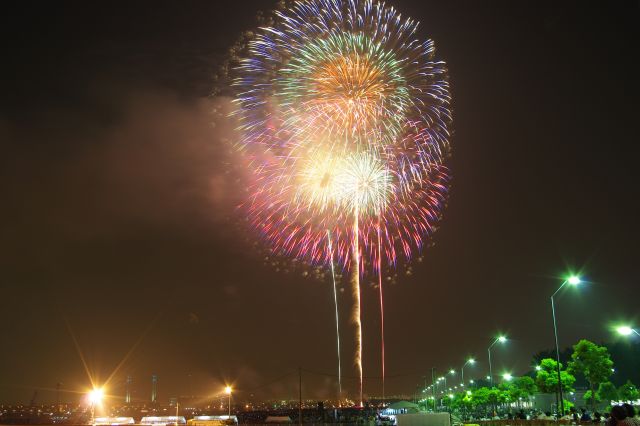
[{"left": 422, "top": 340, "right": 640, "bottom": 412}]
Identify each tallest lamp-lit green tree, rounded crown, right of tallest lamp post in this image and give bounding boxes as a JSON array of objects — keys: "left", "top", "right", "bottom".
[{"left": 569, "top": 339, "right": 613, "bottom": 409}]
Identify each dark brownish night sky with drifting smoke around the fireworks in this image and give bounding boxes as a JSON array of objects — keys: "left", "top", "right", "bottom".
[{"left": 0, "top": 0, "right": 640, "bottom": 402}]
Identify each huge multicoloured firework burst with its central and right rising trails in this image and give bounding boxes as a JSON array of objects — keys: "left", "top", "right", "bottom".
[{"left": 232, "top": 0, "right": 452, "bottom": 402}]
